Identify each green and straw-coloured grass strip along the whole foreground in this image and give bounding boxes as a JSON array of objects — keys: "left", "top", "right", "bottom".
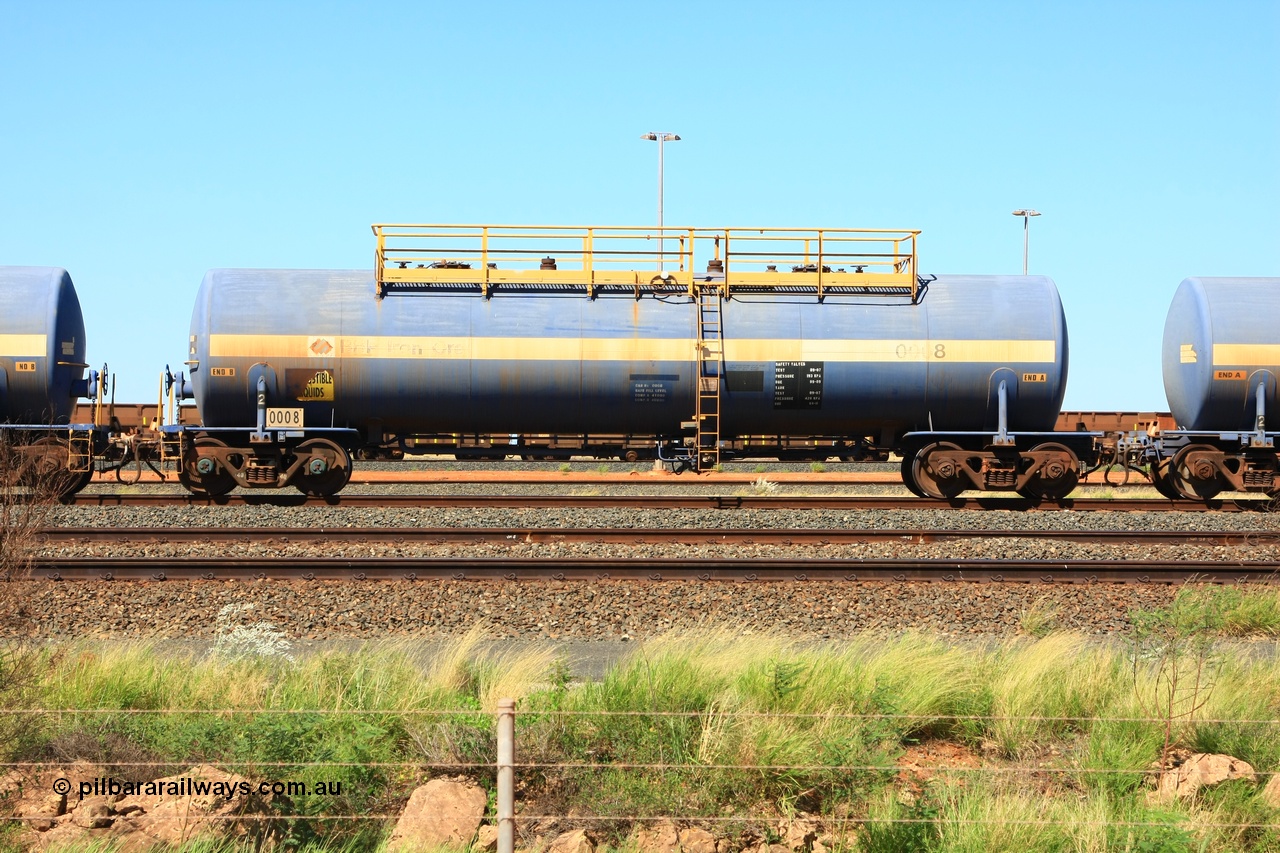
[{"left": 0, "top": 612, "right": 1280, "bottom": 853}]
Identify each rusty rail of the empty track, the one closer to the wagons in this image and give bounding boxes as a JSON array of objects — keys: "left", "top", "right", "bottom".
[{"left": 36, "top": 528, "right": 1280, "bottom": 547}]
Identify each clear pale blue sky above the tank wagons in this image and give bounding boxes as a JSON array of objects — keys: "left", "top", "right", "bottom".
[{"left": 0, "top": 0, "right": 1280, "bottom": 410}]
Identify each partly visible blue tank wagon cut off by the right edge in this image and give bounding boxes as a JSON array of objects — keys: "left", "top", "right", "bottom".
[{"left": 1151, "top": 278, "right": 1280, "bottom": 501}]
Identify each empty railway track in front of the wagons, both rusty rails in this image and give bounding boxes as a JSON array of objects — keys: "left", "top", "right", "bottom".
[{"left": 33, "top": 528, "right": 1280, "bottom": 584}]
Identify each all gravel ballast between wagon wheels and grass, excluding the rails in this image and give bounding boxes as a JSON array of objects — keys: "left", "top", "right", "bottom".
[{"left": 0, "top": 485, "right": 1280, "bottom": 642}]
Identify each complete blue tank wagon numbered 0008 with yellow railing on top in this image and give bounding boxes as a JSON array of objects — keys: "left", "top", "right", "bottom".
[{"left": 182, "top": 225, "right": 1093, "bottom": 498}]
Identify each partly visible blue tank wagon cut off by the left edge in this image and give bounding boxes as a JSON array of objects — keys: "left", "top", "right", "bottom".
[{"left": 0, "top": 266, "right": 105, "bottom": 497}]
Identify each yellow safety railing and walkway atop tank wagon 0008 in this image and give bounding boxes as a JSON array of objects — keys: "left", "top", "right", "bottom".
[{"left": 372, "top": 224, "right": 920, "bottom": 300}]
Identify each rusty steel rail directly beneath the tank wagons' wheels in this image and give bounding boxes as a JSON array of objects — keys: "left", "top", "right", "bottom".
[{"left": 72, "top": 492, "right": 1274, "bottom": 512}]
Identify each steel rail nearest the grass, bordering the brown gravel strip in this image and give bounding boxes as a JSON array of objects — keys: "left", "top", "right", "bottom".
[{"left": 31, "top": 557, "right": 1280, "bottom": 584}]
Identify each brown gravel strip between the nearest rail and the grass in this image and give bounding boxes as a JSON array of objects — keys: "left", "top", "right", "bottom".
[{"left": 9, "top": 571, "right": 1175, "bottom": 640}]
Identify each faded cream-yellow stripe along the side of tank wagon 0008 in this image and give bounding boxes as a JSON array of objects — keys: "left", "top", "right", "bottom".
[{"left": 209, "top": 334, "right": 1057, "bottom": 364}]
